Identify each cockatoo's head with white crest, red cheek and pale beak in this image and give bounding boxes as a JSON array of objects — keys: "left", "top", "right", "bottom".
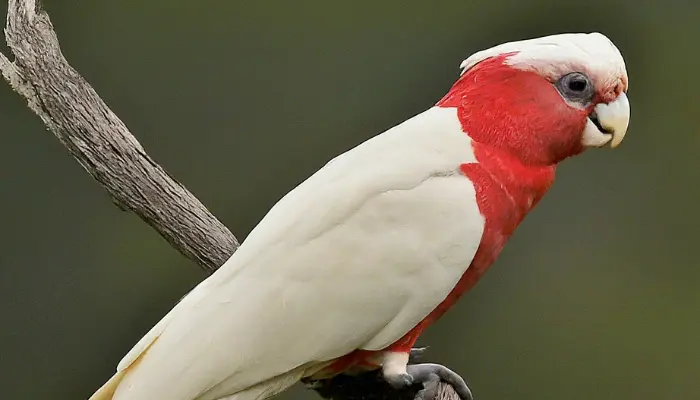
[{"left": 437, "top": 33, "right": 630, "bottom": 165}]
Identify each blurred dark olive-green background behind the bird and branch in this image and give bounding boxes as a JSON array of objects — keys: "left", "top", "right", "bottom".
[{"left": 0, "top": 0, "right": 700, "bottom": 400}]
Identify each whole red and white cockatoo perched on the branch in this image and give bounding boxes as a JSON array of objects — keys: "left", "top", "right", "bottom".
[{"left": 90, "top": 33, "right": 630, "bottom": 400}]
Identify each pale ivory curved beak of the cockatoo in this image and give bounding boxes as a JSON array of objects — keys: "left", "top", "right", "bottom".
[{"left": 582, "top": 93, "right": 630, "bottom": 148}]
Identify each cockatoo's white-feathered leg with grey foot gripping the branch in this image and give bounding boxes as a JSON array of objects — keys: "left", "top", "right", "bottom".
[{"left": 382, "top": 349, "right": 473, "bottom": 400}]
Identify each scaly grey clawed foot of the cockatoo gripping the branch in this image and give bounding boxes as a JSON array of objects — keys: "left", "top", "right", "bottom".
[{"left": 406, "top": 363, "right": 474, "bottom": 400}]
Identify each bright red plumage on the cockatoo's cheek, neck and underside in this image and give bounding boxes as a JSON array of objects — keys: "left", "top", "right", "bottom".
[{"left": 327, "top": 55, "right": 587, "bottom": 375}]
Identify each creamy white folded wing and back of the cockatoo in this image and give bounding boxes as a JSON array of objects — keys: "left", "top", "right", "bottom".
[{"left": 106, "top": 108, "right": 483, "bottom": 400}]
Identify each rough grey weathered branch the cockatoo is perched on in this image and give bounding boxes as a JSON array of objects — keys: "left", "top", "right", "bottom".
[{"left": 0, "top": 0, "right": 458, "bottom": 400}]
